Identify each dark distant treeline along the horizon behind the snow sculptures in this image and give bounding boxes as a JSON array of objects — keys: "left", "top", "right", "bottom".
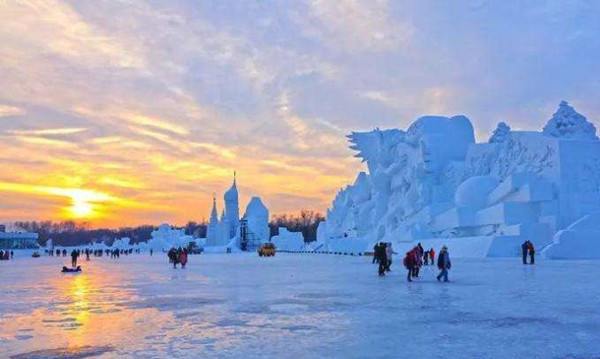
[{"left": 13, "top": 210, "right": 324, "bottom": 246}]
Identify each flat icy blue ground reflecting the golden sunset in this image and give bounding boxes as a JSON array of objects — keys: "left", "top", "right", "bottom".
[{"left": 0, "top": 254, "right": 600, "bottom": 359}]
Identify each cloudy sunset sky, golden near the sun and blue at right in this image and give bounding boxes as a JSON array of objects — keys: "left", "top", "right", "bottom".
[{"left": 0, "top": 0, "right": 600, "bottom": 227}]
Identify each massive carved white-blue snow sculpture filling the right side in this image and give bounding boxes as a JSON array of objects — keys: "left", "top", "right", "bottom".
[{"left": 318, "top": 102, "right": 600, "bottom": 257}]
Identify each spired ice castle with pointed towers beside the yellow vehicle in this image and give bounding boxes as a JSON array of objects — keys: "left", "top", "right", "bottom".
[{"left": 205, "top": 173, "right": 270, "bottom": 250}]
